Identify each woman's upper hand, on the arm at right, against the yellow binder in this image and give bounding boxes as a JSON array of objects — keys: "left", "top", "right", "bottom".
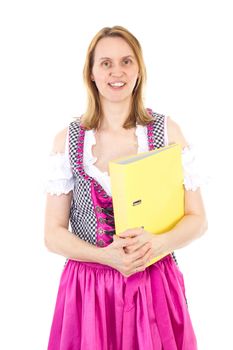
[{"left": 119, "top": 227, "right": 165, "bottom": 259}]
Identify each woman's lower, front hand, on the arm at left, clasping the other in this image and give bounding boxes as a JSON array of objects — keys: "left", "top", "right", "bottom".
[{"left": 102, "top": 235, "right": 152, "bottom": 277}]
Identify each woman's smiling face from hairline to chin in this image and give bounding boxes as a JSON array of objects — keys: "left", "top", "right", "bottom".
[{"left": 91, "top": 37, "right": 139, "bottom": 102}]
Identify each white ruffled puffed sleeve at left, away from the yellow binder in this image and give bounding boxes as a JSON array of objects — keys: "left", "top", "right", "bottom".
[{"left": 44, "top": 129, "right": 74, "bottom": 196}]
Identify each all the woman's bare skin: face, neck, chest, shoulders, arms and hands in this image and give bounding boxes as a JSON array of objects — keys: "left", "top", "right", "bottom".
[{"left": 45, "top": 38, "right": 207, "bottom": 277}]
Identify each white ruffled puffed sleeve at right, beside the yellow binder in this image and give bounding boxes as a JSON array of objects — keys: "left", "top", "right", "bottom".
[{"left": 182, "top": 145, "right": 209, "bottom": 191}]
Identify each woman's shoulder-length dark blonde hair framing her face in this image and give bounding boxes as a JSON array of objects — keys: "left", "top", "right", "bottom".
[{"left": 82, "top": 26, "right": 152, "bottom": 129}]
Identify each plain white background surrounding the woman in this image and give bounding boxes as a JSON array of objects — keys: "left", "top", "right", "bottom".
[{"left": 0, "top": 0, "right": 233, "bottom": 350}]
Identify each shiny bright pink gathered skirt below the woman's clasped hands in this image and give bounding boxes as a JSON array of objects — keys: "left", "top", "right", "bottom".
[{"left": 48, "top": 255, "right": 197, "bottom": 350}]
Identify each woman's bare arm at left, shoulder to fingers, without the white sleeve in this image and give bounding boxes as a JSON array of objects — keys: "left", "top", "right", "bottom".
[{"left": 44, "top": 129, "right": 148, "bottom": 275}]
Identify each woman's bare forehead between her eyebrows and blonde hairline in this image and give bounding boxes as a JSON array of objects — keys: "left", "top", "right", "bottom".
[{"left": 95, "top": 37, "right": 135, "bottom": 59}]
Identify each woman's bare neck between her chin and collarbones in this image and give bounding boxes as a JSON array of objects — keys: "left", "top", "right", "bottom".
[{"left": 99, "top": 99, "right": 132, "bottom": 132}]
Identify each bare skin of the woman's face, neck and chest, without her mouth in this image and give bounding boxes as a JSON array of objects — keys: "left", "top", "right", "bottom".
[{"left": 91, "top": 38, "right": 139, "bottom": 173}]
